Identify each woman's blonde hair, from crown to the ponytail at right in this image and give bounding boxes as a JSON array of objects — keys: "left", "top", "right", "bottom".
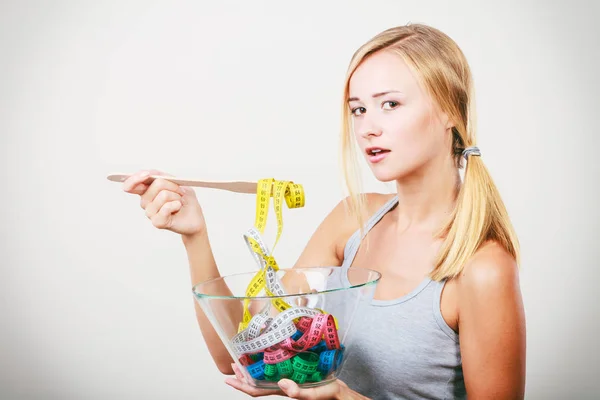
[{"left": 340, "top": 24, "right": 520, "bottom": 280}]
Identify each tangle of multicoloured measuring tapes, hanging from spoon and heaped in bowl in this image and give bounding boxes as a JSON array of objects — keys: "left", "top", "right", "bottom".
[{"left": 231, "top": 178, "right": 344, "bottom": 383}]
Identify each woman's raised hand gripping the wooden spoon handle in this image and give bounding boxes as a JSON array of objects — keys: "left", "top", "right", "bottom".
[{"left": 123, "top": 170, "right": 206, "bottom": 236}]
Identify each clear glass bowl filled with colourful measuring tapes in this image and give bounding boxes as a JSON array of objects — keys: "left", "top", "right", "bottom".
[{"left": 192, "top": 267, "right": 381, "bottom": 389}]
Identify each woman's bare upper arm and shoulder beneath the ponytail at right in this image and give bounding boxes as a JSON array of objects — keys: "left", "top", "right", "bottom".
[{"left": 458, "top": 244, "right": 525, "bottom": 400}]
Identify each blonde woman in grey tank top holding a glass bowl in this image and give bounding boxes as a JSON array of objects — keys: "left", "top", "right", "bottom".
[{"left": 124, "top": 24, "right": 525, "bottom": 399}]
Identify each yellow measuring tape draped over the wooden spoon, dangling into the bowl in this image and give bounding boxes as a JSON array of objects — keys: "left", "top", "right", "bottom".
[{"left": 238, "top": 178, "right": 305, "bottom": 332}]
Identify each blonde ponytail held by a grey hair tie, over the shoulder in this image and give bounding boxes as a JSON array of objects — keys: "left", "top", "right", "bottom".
[{"left": 431, "top": 147, "right": 520, "bottom": 280}]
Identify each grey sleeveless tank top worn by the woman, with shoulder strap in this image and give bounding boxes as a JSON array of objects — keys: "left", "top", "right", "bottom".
[{"left": 330, "top": 197, "right": 467, "bottom": 400}]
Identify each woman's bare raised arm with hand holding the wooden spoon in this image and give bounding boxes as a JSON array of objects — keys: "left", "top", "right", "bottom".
[{"left": 123, "top": 170, "right": 386, "bottom": 375}]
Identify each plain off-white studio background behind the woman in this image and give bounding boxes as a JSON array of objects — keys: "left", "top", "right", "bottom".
[{"left": 0, "top": 1, "right": 600, "bottom": 400}]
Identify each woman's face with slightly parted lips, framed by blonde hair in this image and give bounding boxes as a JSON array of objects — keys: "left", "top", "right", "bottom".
[{"left": 348, "top": 52, "right": 452, "bottom": 182}]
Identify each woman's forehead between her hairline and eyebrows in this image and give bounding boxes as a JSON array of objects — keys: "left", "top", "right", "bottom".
[{"left": 349, "top": 51, "right": 420, "bottom": 99}]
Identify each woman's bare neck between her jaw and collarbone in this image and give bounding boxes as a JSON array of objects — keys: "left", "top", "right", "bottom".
[{"left": 396, "top": 156, "right": 460, "bottom": 232}]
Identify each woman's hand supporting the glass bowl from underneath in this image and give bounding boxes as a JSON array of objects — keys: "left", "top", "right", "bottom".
[{"left": 225, "top": 364, "right": 350, "bottom": 400}]
